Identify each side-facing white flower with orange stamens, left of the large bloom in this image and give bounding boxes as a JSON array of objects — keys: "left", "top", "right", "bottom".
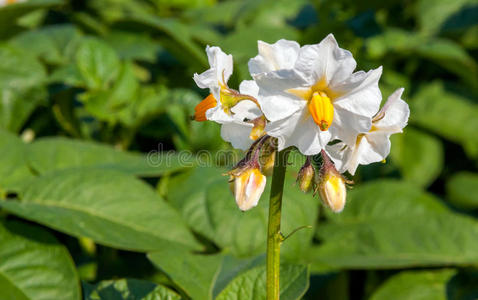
[{"left": 194, "top": 46, "right": 262, "bottom": 150}]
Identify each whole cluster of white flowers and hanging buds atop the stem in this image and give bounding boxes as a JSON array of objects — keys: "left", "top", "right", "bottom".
[{"left": 194, "top": 34, "right": 410, "bottom": 212}]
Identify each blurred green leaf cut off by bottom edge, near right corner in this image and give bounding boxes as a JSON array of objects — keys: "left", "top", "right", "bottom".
[{"left": 370, "top": 269, "right": 456, "bottom": 300}]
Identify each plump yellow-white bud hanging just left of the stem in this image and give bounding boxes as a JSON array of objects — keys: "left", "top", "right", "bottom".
[{"left": 234, "top": 167, "right": 266, "bottom": 211}]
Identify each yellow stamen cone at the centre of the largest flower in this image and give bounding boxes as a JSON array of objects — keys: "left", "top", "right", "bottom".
[{"left": 307, "top": 92, "right": 334, "bottom": 131}]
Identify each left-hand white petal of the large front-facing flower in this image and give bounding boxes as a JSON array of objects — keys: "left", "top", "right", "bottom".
[{"left": 256, "top": 70, "right": 307, "bottom": 121}]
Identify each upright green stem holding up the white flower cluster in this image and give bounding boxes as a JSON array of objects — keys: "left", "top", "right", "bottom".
[{"left": 266, "top": 150, "right": 289, "bottom": 300}]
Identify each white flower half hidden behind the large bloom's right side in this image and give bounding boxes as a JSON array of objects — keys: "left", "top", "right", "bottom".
[{"left": 326, "top": 88, "right": 410, "bottom": 175}]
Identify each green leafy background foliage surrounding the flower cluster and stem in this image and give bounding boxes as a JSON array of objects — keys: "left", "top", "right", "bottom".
[{"left": 0, "top": 0, "right": 478, "bottom": 300}]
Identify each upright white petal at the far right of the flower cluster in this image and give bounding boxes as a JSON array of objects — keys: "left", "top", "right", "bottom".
[{"left": 374, "top": 88, "right": 410, "bottom": 133}]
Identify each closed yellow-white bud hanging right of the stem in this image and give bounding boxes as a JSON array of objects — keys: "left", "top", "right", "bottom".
[{"left": 318, "top": 170, "right": 347, "bottom": 213}]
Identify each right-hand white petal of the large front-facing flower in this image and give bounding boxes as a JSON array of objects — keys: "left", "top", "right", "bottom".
[{"left": 330, "top": 67, "right": 382, "bottom": 117}]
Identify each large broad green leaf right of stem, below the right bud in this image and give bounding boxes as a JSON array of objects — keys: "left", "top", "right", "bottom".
[{"left": 310, "top": 180, "right": 478, "bottom": 270}]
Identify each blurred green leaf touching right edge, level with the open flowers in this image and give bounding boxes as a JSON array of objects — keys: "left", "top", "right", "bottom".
[{"left": 410, "top": 82, "right": 478, "bottom": 157}]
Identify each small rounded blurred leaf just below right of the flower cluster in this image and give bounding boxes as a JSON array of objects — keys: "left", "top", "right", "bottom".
[{"left": 390, "top": 128, "right": 444, "bottom": 186}]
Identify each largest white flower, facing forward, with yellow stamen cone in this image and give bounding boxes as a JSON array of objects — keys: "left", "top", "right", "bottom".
[{"left": 249, "top": 34, "right": 382, "bottom": 155}]
